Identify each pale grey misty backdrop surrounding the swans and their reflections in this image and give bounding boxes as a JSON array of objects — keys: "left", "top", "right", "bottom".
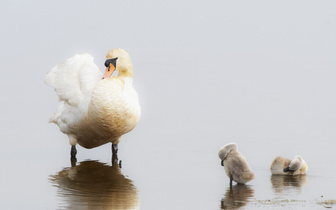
[{"left": 0, "top": 0, "right": 336, "bottom": 209}]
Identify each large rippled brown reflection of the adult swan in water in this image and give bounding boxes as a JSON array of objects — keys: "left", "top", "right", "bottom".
[{"left": 50, "top": 160, "right": 140, "bottom": 209}]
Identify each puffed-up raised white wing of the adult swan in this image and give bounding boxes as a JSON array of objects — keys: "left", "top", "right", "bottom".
[{"left": 45, "top": 54, "right": 102, "bottom": 106}]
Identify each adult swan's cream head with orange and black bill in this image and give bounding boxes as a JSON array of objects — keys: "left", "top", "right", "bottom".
[{"left": 103, "top": 48, "right": 133, "bottom": 79}]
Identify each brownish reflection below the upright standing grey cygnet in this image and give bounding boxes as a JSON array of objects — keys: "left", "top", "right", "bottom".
[{"left": 221, "top": 184, "right": 254, "bottom": 209}]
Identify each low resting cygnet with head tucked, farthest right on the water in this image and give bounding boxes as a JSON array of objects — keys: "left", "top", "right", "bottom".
[{"left": 270, "top": 155, "right": 308, "bottom": 175}]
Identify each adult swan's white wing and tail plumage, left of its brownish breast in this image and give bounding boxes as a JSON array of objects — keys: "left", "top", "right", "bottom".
[{"left": 45, "top": 54, "right": 102, "bottom": 134}]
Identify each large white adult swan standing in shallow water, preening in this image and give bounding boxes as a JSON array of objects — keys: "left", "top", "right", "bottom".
[{"left": 45, "top": 48, "right": 141, "bottom": 156}]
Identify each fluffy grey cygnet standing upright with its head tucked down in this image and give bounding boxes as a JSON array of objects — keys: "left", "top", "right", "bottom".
[{"left": 218, "top": 143, "right": 254, "bottom": 186}]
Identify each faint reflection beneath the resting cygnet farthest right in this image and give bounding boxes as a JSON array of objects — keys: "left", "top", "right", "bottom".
[{"left": 271, "top": 175, "right": 307, "bottom": 193}]
